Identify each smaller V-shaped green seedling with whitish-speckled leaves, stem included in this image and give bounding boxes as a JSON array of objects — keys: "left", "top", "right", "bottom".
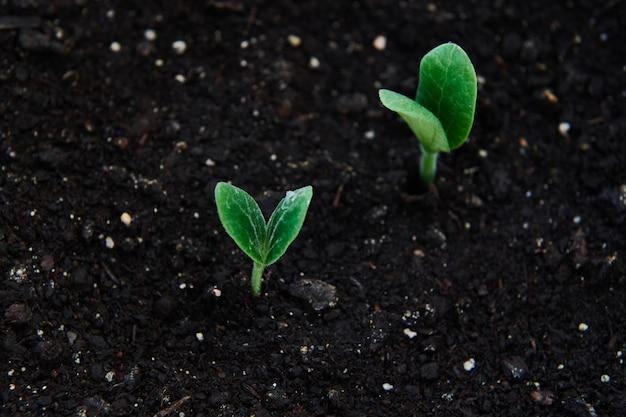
[{"left": 215, "top": 182, "right": 313, "bottom": 297}]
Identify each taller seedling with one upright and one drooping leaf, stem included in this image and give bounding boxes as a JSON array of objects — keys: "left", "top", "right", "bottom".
[{"left": 378, "top": 43, "right": 477, "bottom": 184}]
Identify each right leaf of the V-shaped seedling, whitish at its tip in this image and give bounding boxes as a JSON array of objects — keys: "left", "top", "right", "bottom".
[{"left": 265, "top": 186, "right": 313, "bottom": 265}]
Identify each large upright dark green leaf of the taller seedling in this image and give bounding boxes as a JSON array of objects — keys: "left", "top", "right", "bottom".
[{"left": 416, "top": 42, "right": 477, "bottom": 149}]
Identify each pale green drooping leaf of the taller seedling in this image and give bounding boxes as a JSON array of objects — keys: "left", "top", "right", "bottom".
[{"left": 378, "top": 90, "right": 450, "bottom": 152}]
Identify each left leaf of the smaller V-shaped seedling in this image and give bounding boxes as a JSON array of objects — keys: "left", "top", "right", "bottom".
[{"left": 215, "top": 182, "right": 267, "bottom": 264}]
